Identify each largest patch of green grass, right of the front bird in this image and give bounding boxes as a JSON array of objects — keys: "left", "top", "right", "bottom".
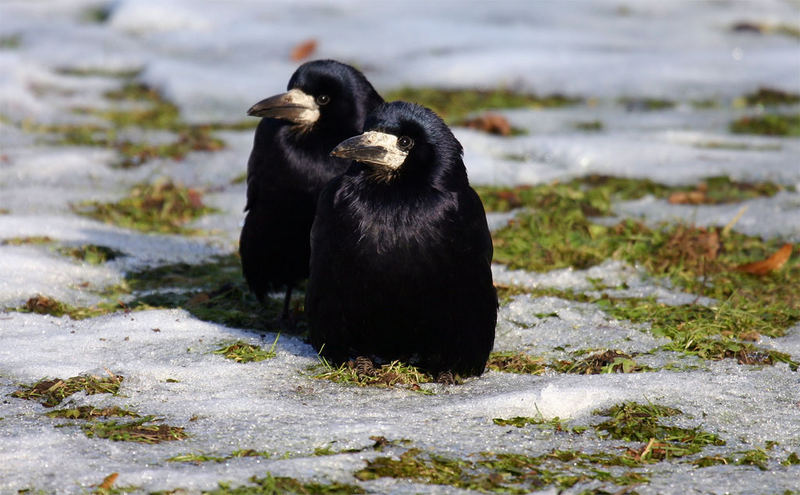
[{"left": 479, "top": 177, "right": 800, "bottom": 369}]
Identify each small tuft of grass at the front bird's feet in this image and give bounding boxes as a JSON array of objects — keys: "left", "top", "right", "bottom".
[{"left": 314, "top": 358, "right": 433, "bottom": 391}]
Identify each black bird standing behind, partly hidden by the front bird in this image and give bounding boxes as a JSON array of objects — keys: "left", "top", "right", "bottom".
[{"left": 239, "top": 60, "right": 383, "bottom": 319}]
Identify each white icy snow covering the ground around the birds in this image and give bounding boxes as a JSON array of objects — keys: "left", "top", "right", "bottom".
[{"left": 0, "top": 0, "right": 800, "bottom": 493}]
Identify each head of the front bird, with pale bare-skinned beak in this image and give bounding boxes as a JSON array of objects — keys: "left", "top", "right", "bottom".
[{"left": 331, "top": 101, "right": 466, "bottom": 182}]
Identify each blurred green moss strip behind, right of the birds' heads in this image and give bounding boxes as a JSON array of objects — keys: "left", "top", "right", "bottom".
[{"left": 385, "top": 87, "right": 581, "bottom": 123}]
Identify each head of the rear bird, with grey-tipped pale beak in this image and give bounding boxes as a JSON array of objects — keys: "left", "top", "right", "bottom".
[{"left": 247, "top": 60, "right": 383, "bottom": 135}]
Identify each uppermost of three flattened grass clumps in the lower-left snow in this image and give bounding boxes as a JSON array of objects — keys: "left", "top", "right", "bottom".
[{"left": 11, "top": 375, "right": 123, "bottom": 407}]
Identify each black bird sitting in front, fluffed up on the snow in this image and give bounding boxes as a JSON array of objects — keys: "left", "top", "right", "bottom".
[{"left": 306, "top": 102, "right": 497, "bottom": 379}]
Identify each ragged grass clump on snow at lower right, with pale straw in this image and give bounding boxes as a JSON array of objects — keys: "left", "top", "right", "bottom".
[{"left": 594, "top": 402, "right": 725, "bottom": 461}]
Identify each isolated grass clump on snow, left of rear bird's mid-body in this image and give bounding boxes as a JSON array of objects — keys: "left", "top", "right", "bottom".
[{"left": 73, "top": 180, "right": 216, "bottom": 233}]
